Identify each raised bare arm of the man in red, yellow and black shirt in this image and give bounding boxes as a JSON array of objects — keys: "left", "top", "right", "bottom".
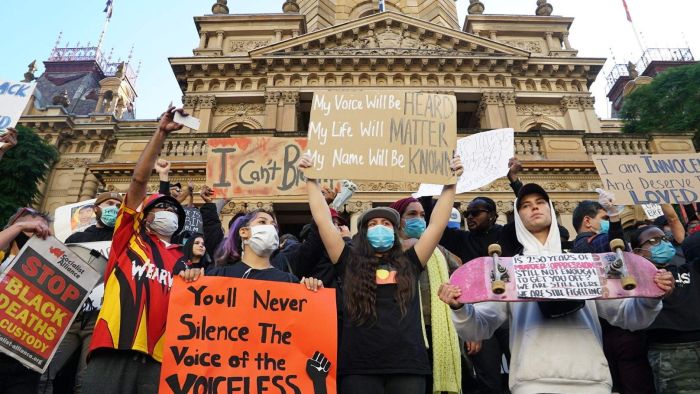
[{"left": 124, "top": 106, "right": 186, "bottom": 210}]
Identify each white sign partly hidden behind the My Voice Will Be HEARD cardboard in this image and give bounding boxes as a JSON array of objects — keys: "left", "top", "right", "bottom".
[{"left": 413, "top": 129, "right": 515, "bottom": 198}]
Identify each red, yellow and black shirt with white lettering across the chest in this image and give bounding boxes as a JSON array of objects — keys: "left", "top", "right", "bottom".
[{"left": 90, "top": 196, "right": 186, "bottom": 362}]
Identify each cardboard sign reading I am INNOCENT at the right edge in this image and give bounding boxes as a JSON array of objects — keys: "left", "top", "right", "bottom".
[{"left": 592, "top": 153, "right": 700, "bottom": 205}]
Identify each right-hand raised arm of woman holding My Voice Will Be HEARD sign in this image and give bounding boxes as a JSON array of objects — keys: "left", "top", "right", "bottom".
[{"left": 413, "top": 157, "right": 463, "bottom": 266}]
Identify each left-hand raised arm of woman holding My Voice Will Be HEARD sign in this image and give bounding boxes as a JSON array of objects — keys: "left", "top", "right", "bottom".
[{"left": 298, "top": 153, "right": 348, "bottom": 264}]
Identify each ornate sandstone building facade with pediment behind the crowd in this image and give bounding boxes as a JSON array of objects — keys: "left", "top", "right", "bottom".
[{"left": 16, "top": 0, "right": 695, "bottom": 234}]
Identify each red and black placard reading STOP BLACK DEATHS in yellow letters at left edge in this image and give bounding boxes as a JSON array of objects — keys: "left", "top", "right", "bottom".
[{"left": 0, "top": 237, "right": 100, "bottom": 373}]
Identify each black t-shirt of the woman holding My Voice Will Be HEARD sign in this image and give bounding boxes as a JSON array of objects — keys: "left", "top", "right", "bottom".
[{"left": 337, "top": 245, "right": 431, "bottom": 375}]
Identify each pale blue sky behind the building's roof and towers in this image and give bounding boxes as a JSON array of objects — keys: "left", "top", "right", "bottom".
[{"left": 0, "top": 0, "right": 700, "bottom": 119}]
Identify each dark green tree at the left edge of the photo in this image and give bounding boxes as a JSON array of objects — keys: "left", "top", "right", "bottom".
[{"left": 0, "top": 126, "right": 58, "bottom": 228}]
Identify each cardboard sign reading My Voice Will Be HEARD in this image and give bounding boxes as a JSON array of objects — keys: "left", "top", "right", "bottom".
[{"left": 306, "top": 91, "right": 457, "bottom": 184}]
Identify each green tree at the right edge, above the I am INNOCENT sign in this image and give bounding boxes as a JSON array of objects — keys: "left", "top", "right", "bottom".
[{"left": 621, "top": 63, "right": 700, "bottom": 145}]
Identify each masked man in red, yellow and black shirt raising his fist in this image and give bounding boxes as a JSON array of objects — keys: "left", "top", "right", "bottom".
[{"left": 83, "top": 107, "right": 202, "bottom": 394}]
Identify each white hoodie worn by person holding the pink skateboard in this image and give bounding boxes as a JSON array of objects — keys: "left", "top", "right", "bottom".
[{"left": 452, "top": 203, "right": 661, "bottom": 394}]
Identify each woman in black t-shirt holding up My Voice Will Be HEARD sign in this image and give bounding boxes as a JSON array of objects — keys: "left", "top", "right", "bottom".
[{"left": 299, "top": 154, "right": 462, "bottom": 394}]
